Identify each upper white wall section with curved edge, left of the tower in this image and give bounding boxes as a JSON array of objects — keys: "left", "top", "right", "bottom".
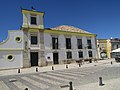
[{"left": 0, "top": 30, "right": 24, "bottom": 49}]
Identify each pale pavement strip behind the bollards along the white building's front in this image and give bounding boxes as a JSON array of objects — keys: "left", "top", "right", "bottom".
[{"left": 0, "top": 59, "right": 111, "bottom": 76}]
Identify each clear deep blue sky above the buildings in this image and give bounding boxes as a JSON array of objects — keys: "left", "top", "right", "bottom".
[{"left": 0, "top": 0, "right": 120, "bottom": 42}]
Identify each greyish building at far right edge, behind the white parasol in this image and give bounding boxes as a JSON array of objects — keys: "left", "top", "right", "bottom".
[{"left": 110, "top": 38, "right": 120, "bottom": 58}]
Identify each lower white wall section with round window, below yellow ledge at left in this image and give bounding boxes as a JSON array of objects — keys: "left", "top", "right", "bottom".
[{"left": 0, "top": 51, "right": 23, "bottom": 69}]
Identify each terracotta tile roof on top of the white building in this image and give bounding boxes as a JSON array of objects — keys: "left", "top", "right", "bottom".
[{"left": 50, "top": 25, "right": 92, "bottom": 34}]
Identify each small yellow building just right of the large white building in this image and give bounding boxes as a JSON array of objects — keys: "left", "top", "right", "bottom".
[{"left": 97, "top": 39, "right": 111, "bottom": 59}]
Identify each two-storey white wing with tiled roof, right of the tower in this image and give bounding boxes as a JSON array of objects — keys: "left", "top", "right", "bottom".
[{"left": 44, "top": 25, "right": 97, "bottom": 64}]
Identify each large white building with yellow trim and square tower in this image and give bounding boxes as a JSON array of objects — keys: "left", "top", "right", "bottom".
[{"left": 0, "top": 9, "right": 97, "bottom": 69}]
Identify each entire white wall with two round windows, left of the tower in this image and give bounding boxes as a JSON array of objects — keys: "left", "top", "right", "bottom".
[{"left": 0, "top": 30, "right": 24, "bottom": 69}]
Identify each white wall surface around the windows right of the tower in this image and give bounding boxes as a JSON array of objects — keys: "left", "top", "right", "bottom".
[{"left": 44, "top": 33, "right": 96, "bottom": 61}]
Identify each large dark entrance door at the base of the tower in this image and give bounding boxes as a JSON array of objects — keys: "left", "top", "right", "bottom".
[{"left": 30, "top": 52, "right": 38, "bottom": 66}]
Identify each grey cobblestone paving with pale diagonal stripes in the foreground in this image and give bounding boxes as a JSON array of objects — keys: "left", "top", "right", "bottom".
[{"left": 0, "top": 66, "right": 104, "bottom": 90}]
